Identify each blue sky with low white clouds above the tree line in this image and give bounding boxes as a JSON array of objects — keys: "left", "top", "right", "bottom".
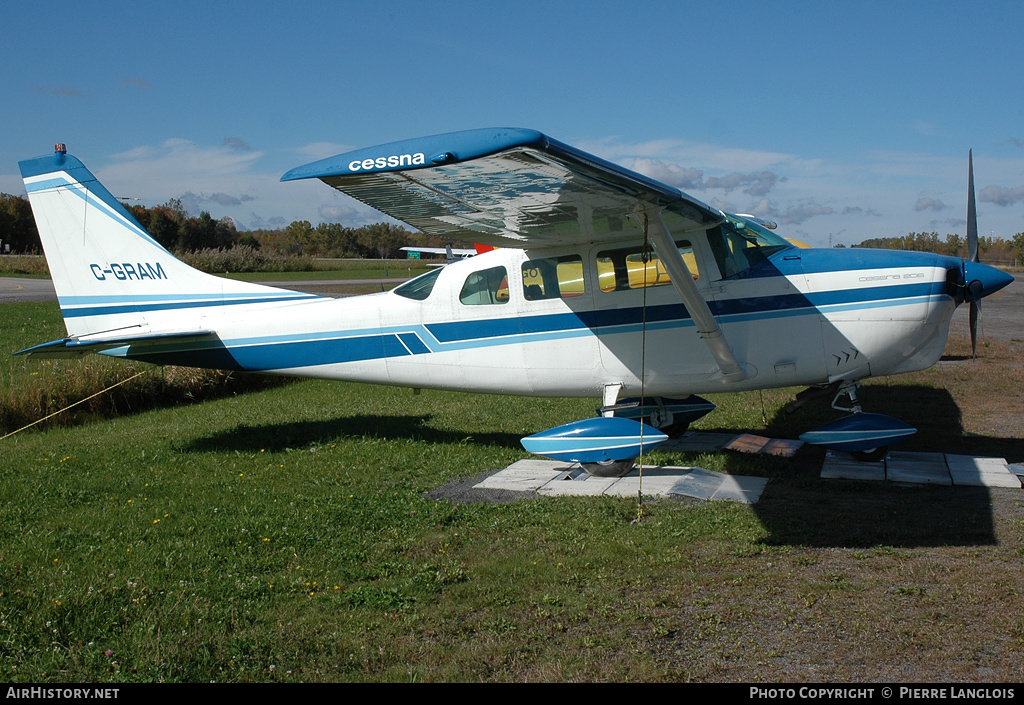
[{"left": 0, "top": 0, "right": 1024, "bottom": 247}]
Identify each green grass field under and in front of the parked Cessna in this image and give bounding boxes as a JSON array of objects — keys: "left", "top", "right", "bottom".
[{"left": 0, "top": 304, "right": 1024, "bottom": 682}]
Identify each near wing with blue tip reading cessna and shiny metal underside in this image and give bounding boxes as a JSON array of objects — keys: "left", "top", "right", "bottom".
[{"left": 282, "top": 128, "right": 724, "bottom": 247}]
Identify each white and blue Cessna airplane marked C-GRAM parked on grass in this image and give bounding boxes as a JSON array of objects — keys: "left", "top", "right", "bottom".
[{"left": 20, "top": 128, "right": 1013, "bottom": 474}]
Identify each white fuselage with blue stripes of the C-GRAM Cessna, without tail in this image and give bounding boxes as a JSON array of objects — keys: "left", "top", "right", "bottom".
[{"left": 108, "top": 231, "right": 974, "bottom": 398}]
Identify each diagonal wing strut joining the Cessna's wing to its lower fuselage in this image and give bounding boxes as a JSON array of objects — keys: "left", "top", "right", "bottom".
[{"left": 645, "top": 206, "right": 753, "bottom": 383}]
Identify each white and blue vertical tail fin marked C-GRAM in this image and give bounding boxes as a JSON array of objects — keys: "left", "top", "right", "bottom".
[{"left": 19, "top": 144, "right": 316, "bottom": 338}]
